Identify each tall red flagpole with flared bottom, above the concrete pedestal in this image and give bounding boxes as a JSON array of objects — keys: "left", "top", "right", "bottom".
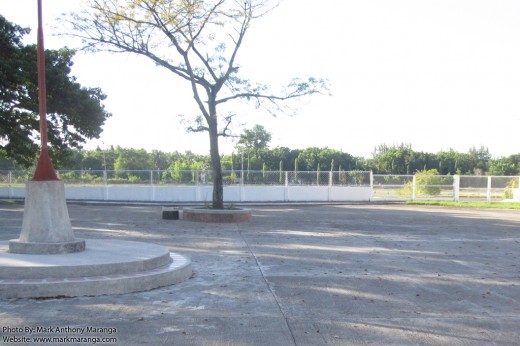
[{"left": 33, "top": 0, "right": 58, "bottom": 180}]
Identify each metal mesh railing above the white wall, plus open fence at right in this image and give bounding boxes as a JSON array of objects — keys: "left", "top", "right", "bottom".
[{"left": 0, "top": 170, "right": 520, "bottom": 201}]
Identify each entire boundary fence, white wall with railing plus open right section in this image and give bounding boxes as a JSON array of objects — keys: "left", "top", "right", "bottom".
[{"left": 0, "top": 171, "right": 520, "bottom": 203}]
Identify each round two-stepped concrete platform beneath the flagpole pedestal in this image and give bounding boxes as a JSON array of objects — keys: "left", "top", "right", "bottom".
[{"left": 0, "top": 239, "right": 192, "bottom": 299}]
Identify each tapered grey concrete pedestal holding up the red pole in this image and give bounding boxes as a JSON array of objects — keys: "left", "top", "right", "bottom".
[{"left": 9, "top": 180, "right": 85, "bottom": 254}]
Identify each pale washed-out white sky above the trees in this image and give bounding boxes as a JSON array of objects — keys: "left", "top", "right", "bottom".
[{"left": 0, "top": 0, "right": 520, "bottom": 158}]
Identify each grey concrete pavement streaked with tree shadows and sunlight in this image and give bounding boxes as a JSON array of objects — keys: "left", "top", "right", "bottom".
[{"left": 0, "top": 203, "right": 520, "bottom": 346}]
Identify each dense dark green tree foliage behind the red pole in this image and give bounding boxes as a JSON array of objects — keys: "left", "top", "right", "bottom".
[{"left": 0, "top": 15, "right": 110, "bottom": 166}]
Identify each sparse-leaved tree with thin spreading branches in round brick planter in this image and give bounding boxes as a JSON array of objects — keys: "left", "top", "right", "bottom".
[{"left": 64, "top": 0, "right": 328, "bottom": 209}]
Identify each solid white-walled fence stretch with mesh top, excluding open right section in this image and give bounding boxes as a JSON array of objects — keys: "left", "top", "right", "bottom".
[{"left": 0, "top": 171, "right": 371, "bottom": 203}]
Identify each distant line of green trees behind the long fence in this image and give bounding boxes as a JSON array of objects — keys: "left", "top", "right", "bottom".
[{"left": 0, "top": 144, "right": 520, "bottom": 176}]
